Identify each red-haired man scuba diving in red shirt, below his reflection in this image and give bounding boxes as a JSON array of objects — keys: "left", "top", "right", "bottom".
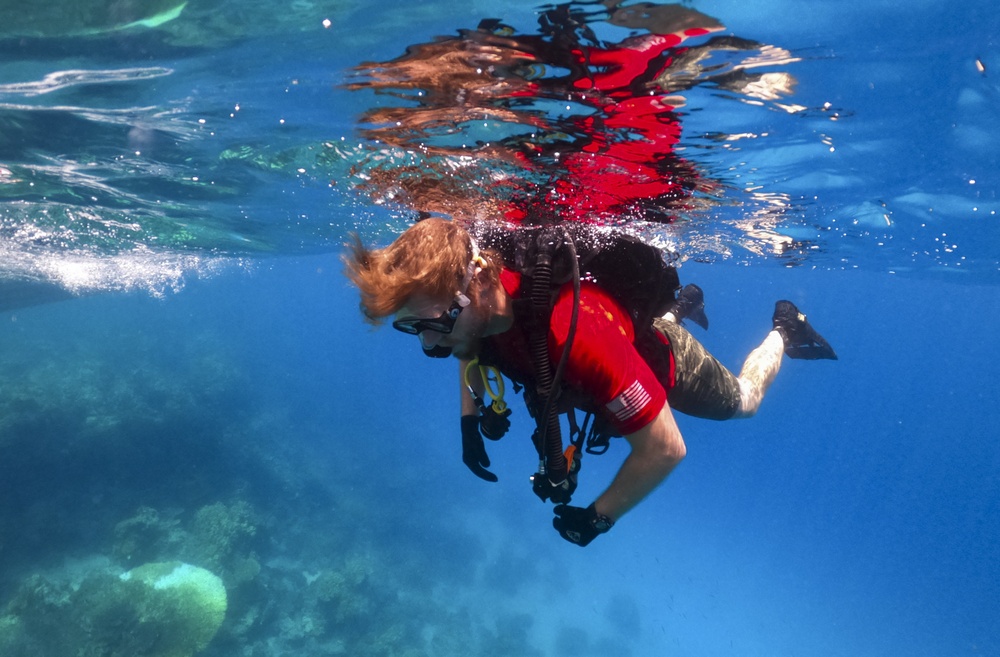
[{"left": 344, "top": 218, "right": 837, "bottom": 546}]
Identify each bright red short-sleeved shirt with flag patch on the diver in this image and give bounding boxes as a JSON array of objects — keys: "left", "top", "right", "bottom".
[{"left": 488, "top": 269, "right": 672, "bottom": 435}]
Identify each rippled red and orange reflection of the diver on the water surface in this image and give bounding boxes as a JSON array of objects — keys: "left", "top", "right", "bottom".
[{"left": 347, "top": 0, "right": 794, "bottom": 229}]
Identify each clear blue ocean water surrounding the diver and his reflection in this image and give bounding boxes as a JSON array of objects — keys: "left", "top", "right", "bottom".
[{"left": 0, "top": 0, "right": 1000, "bottom": 657}]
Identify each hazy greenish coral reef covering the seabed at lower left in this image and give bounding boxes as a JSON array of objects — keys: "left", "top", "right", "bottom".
[{"left": 0, "top": 302, "right": 552, "bottom": 657}]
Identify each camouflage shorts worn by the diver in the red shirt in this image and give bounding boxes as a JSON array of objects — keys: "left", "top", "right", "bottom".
[{"left": 653, "top": 319, "right": 740, "bottom": 420}]
